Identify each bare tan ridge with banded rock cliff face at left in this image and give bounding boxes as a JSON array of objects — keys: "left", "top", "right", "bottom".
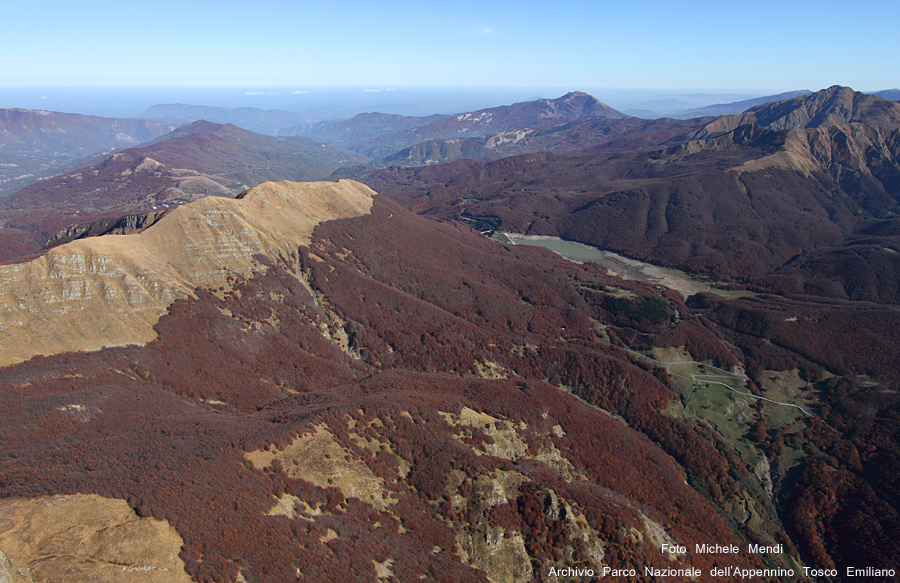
[{"left": 0, "top": 181, "right": 374, "bottom": 365}]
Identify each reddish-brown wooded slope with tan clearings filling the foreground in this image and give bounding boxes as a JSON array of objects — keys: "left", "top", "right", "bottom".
[{"left": 0, "top": 187, "right": 790, "bottom": 581}]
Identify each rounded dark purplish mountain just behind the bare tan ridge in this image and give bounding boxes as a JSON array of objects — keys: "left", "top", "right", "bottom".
[{"left": 7, "top": 121, "right": 361, "bottom": 212}]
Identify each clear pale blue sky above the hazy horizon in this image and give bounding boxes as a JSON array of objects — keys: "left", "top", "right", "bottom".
[{"left": 0, "top": 0, "right": 900, "bottom": 92}]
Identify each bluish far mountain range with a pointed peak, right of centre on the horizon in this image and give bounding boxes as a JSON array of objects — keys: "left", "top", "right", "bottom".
[{"left": 121, "top": 90, "right": 900, "bottom": 176}]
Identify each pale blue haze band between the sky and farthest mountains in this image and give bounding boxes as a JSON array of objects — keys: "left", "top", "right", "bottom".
[{"left": 0, "top": 86, "right": 890, "bottom": 121}]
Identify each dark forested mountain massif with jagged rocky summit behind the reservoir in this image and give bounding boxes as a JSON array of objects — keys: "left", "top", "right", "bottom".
[{"left": 356, "top": 87, "right": 900, "bottom": 301}]
